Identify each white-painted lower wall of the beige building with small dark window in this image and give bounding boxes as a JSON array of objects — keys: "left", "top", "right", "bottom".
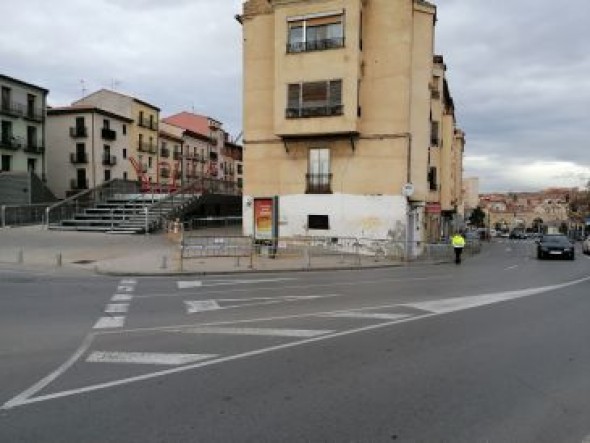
[{"left": 243, "top": 194, "right": 410, "bottom": 241}]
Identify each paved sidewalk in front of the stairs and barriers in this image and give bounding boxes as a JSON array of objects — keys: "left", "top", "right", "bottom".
[{"left": 0, "top": 226, "right": 403, "bottom": 276}]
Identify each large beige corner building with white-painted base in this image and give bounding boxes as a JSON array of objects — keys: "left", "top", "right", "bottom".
[{"left": 239, "top": 0, "right": 462, "bottom": 242}]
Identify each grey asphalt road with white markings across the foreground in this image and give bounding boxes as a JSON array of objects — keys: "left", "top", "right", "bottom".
[{"left": 0, "top": 242, "right": 590, "bottom": 443}]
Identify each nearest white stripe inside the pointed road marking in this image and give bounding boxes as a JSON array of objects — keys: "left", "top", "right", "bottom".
[{"left": 86, "top": 351, "right": 219, "bottom": 366}]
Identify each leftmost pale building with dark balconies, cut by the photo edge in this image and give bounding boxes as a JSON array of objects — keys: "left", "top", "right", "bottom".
[{"left": 0, "top": 74, "right": 49, "bottom": 179}]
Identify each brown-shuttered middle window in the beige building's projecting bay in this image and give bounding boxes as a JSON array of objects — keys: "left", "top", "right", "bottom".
[{"left": 286, "top": 80, "right": 344, "bottom": 118}]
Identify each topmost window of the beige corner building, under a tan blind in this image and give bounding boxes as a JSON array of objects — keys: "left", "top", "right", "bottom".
[{"left": 287, "top": 11, "right": 344, "bottom": 53}]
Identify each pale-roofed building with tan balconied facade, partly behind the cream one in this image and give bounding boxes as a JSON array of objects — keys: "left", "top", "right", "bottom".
[{"left": 72, "top": 89, "right": 160, "bottom": 187}]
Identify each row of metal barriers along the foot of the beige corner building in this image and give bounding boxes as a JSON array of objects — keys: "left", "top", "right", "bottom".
[{"left": 181, "top": 232, "right": 481, "bottom": 267}]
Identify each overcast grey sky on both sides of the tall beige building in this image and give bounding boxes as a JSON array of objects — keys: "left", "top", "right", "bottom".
[{"left": 0, "top": 0, "right": 590, "bottom": 192}]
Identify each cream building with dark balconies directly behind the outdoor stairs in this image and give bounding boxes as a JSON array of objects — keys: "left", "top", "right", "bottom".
[{"left": 47, "top": 105, "right": 135, "bottom": 198}]
